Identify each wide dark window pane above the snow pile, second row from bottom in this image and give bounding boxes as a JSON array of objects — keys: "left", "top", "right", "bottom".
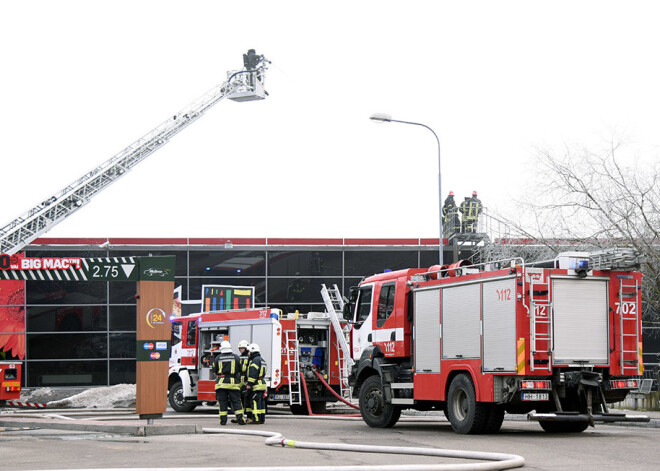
[{"left": 26, "top": 334, "right": 108, "bottom": 364}]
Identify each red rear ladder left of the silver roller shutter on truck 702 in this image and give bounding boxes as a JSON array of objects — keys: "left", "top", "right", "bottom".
[{"left": 529, "top": 276, "right": 552, "bottom": 372}]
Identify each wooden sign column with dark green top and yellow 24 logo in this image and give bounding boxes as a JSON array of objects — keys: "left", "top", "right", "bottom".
[{"left": 135, "top": 256, "right": 176, "bottom": 420}]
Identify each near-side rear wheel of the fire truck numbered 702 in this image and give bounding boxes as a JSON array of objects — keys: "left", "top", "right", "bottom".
[{"left": 447, "top": 374, "right": 488, "bottom": 434}]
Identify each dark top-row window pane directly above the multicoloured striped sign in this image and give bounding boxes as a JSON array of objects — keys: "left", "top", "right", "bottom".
[{"left": 190, "top": 249, "right": 266, "bottom": 277}]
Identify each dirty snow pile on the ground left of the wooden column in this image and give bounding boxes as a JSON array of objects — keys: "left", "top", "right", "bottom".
[{"left": 20, "top": 384, "right": 135, "bottom": 409}]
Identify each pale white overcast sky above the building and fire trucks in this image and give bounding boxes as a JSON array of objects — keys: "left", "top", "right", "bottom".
[{"left": 0, "top": 0, "right": 660, "bottom": 243}]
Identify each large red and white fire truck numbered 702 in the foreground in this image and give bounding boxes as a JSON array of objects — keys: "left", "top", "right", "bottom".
[{"left": 344, "top": 250, "right": 649, "bottom": 433}]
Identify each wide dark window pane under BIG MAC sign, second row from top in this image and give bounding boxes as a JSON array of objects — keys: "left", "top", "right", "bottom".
[{"left": 26, "top": 306, "right": 108, "bottom": 332}]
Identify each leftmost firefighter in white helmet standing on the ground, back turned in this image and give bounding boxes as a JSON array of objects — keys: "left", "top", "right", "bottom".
[{"left": 212, "top": 340, "right": 245, "bottom": 425}]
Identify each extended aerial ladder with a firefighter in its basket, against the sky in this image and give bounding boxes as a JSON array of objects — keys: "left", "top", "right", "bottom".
[{"left": 0, "top": 49, "right": 270, "bottom": 254}]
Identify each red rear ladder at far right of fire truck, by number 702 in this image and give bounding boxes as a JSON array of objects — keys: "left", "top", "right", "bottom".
[{"left": 616, "top": 278, "right": 641, "bottom": 375}]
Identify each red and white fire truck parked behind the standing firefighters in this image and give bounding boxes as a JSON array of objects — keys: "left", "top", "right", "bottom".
[{"left": 169, "top": 296, "right": 349, "bottom": 414}]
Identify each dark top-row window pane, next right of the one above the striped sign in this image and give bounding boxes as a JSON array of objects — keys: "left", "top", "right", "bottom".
[{"left": 268, "top": 250, "right": 342, "bottom": 276}]
